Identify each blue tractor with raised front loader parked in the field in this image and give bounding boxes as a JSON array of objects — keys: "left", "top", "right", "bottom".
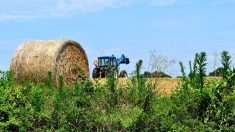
[{"left": 92, "top": 54, "right": 130, "bottom": 79}]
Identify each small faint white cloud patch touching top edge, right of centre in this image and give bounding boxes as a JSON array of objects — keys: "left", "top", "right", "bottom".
[{"left": 150, "top": 0, "right": 191, "bottom": 6}]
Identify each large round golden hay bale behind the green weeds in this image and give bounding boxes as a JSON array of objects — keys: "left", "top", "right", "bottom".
[{"left": 10, "top": 40, "right": 89, "bottom": 86}]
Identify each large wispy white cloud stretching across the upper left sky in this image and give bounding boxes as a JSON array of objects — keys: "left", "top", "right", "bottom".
[{"left": 0, "top": 0, "right": 133, "bottom": 21}]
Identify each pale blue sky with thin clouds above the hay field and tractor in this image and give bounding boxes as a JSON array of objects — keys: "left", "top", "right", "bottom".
[{"left": 0, "top": 0, "right": 235, "bottom": 76}]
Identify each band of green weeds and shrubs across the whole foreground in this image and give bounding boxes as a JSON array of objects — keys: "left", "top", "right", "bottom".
[{"left": 0, "top": 52, "right": 235, "bottom": 131}]
